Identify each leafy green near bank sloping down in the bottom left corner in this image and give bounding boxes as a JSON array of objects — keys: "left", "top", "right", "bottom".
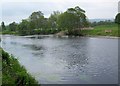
[{"left": 0, "top": 48, "right": 38, "bottom": 86}]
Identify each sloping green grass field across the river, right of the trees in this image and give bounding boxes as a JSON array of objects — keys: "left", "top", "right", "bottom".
[{"left": 80, "top": 24, "right": 120, "bottom": 37}]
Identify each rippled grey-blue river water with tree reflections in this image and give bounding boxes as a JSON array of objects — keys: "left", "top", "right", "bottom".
[{"left": 2, "top": 36, "right": 118, "bottom": 84}]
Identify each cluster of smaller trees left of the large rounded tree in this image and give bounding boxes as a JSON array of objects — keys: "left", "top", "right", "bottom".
[{"left": 1, "top": 11, "right": 61, "bottom": 35}]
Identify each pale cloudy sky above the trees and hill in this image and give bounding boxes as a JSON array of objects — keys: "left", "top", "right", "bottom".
[{"left": 0, "top": 0, "right": 119, "bottom": 24}]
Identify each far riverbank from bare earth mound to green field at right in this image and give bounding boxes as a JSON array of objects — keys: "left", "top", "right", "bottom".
[{"left": 55, "top": 24, "right": 120, "bottom": 38}]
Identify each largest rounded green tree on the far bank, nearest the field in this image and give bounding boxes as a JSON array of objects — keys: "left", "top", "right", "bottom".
[{"left": 57, "top": 6, "right": 88, "bottom": 30}]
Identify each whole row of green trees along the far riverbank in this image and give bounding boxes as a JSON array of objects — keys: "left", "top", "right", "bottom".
[{"left": 1, "top": 6, "right": 89, "bottom": 35}]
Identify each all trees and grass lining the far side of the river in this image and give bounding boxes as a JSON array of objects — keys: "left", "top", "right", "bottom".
[{"left": 0, "top": 6, "right": 120, "bottom": 36}]
